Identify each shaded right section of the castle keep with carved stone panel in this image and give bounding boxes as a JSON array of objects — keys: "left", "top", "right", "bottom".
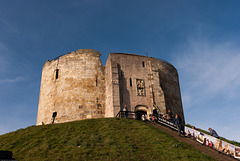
[{"left": 106, "top": 53, "right": 184, "bottom": 120}]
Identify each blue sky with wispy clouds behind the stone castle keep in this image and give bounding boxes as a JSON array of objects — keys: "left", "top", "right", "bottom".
[{"left": 0, "top": 0, "right": 240, "bottom": 141}]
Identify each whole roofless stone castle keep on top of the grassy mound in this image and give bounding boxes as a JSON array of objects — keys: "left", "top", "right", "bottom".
[{"left": 37, "top": 49, "right": 184, "bottom": 125}]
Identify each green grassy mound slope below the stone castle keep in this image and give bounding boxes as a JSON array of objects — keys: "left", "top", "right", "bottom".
[{"left": 0, "top": 118, "right": 213, "bottom": 161}]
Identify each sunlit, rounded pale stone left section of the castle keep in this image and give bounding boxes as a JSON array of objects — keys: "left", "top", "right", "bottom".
[{"left": 37, "top": 49, "right": 105, "bottom": 125}]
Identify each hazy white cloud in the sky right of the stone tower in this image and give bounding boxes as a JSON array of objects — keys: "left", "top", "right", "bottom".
[{"left": 174, "top": 39, "right": 240, "bottom": 141}]
